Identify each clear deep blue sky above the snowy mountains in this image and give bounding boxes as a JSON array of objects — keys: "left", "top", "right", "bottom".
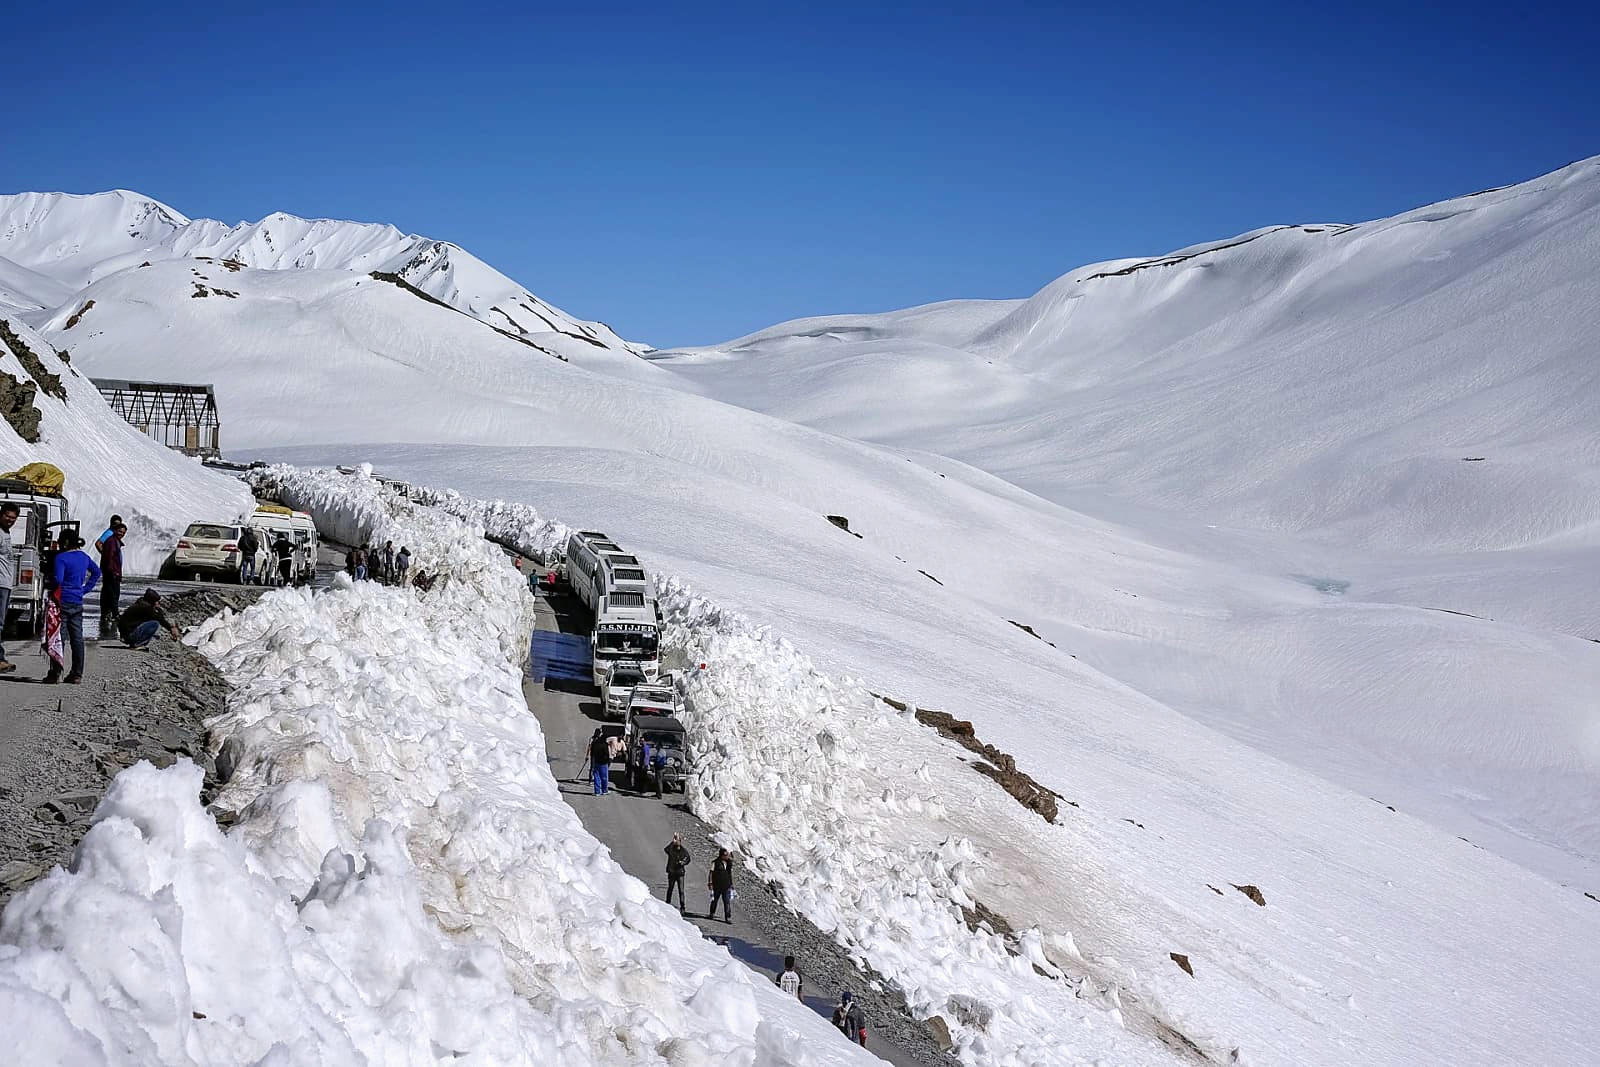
[{"left": 0, "top": 0, "right": 1600, "bottom": 346}]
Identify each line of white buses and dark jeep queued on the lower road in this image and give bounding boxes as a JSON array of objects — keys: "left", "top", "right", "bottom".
[{"left": 555, "top": 530, "right": 690, "bottom": 797}]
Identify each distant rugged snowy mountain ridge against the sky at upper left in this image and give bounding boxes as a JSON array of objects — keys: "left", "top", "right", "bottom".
[{"left": 0, "top": 189, "right": 645, "bottom": 352}]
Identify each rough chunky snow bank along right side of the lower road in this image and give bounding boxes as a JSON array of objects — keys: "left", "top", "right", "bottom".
[{"left": 659, "top": 579, "right": 1168, "bottom": 1064}]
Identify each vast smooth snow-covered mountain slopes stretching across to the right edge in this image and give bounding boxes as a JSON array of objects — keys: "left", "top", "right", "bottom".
[{"left": 9, "top": 160, "right": 1600, "bottom": 1064}]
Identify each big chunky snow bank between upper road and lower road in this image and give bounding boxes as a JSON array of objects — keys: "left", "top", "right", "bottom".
[{"left": 0, "top": 470, "right": 866, "bottom": 1065}]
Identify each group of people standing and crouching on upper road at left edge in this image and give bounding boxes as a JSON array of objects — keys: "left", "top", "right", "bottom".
[{"left": 0, "top": 502, "right": 178, "bottom": 685}]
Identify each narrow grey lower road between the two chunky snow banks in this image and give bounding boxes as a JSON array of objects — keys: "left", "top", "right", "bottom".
[{"left": 523, "top": 593, "right": 955, "bottom": 1067}]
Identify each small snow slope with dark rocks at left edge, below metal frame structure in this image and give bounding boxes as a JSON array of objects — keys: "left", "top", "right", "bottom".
[{"left": 0, "top": 317, "right": 254, "bottom": 574}]
